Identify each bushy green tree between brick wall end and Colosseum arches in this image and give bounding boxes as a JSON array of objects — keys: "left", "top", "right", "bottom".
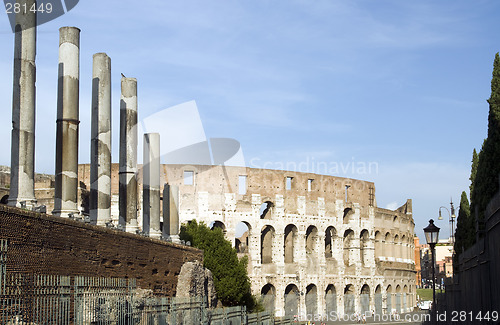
[{"left": 180, "top": 220, "right": 256, "bottom": 310}]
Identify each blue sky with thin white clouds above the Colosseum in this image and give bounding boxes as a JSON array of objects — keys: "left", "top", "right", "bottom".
[{"left": 0, "top": 0, "right": 500, "bottom": 239}]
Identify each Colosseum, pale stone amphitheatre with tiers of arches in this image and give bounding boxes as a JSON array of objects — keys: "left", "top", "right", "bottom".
[{"left": 75, "top": 164, "right": 416, "bottom": 316}]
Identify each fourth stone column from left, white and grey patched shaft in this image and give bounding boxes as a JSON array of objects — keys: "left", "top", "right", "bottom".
[{"left": 119, "top": 78, "right": 139, "bottom": 233}]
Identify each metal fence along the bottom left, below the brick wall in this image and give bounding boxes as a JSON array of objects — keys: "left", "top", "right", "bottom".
[{"left": 0, "top": 240, "right": 291, "bottom": 325}]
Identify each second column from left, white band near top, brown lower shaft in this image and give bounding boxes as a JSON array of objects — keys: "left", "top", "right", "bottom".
[{"left": 52, "top": 27, "right": 80, "bottom": 217}]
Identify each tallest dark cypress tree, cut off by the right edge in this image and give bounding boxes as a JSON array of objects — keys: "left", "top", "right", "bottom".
[{"left": 471, "top": 53, "right": 500, "bottom": 224}]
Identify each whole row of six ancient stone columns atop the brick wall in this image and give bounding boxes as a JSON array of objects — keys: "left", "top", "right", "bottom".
[{"left": 8, "top": 15, "right": 179, "bottom": 239}]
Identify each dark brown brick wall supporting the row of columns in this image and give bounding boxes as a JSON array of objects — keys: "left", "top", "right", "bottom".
[{"left": 0, "top": 204, "right": 203, "bottom": 296}]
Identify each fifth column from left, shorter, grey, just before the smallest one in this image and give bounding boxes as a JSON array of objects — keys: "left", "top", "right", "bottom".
[{"left": 142, "top": 133, "right": 161, "bottom": 238}]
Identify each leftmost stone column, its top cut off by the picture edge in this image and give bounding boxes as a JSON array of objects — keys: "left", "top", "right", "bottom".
[{"left": 8, "top": 0, "right": 36, "bottom": 208}]
